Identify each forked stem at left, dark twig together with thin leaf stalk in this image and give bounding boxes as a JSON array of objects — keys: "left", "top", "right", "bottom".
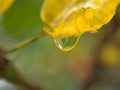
[{"left": 0, "top": 31, "right": 47, "bottom": 90}]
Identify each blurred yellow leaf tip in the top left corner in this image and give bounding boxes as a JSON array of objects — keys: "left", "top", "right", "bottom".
[{"left": 0, "top": 0, "right": 13, "bottom": 15}]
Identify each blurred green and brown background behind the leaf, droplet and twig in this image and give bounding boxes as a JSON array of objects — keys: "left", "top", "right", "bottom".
[{"left": 0, "top": 0, "right": 120, "bottom": 90}]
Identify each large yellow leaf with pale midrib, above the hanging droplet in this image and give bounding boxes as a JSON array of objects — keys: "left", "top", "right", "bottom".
[{"left": 41, "top": 0, "right": 120, "bottom": 51}]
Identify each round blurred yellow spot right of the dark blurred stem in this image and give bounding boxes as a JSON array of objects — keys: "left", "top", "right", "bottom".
[{"left": 101, "top": 43, "right": 120, "bottom": 68}]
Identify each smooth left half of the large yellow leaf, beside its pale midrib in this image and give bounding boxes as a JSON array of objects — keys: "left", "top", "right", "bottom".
[{"left": 41, "top": 0, "right": 73, "bottom": 25}]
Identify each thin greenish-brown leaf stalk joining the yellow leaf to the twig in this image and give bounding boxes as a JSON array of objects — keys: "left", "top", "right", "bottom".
[{"left": 6, "top": 31, "right": 47, "bottom": 53}]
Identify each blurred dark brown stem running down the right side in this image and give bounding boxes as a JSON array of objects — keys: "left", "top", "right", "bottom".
[{"left": 82, "top": 6, "right": 120, "bottom": 90}]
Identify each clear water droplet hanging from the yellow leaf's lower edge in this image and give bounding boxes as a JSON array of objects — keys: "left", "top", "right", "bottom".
[{"left": 55, "top": 36, "right": 79, "bottom": 51}]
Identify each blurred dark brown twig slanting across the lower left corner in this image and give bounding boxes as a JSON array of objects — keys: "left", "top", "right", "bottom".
[{"left": 0, "top": 50, "right": 43, "bottom": 90}]
